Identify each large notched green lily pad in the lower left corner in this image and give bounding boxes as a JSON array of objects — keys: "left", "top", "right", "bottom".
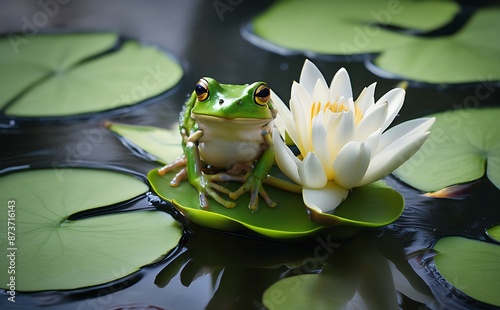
[{"left": 0, "top": 168, "right": 181, "bottom": 291}]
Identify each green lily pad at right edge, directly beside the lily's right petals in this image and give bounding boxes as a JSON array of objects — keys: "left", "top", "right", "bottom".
[{"left": 394, "top": 108, "right": 500, "bottom": 192}]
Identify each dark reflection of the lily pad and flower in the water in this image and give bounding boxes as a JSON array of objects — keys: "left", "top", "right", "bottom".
[{"left": 155, "top": 226, "right": 433, "bottom": 309}]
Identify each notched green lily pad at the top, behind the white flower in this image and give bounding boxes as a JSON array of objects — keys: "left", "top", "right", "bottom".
[{"left": 251, "top": 0, "right": 459, "bottom": 55}]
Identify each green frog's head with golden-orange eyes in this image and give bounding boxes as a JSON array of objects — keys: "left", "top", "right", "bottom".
[{"left": 192, "top": 77, "right": 276, "bottom": 119}]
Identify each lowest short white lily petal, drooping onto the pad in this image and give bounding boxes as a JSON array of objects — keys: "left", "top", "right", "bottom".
[{"left": 302, "top": 182, "right": 349, "bottom": 213}]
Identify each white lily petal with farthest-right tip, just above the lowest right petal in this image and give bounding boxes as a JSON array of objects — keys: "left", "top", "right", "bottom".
[{"left": 376, "top": 117, "right": 436, "bottom": 153}]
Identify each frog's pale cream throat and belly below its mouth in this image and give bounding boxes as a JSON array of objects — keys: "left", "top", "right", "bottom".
[{"left": 191, "top": 113, "right": 273, "bottom": 169}]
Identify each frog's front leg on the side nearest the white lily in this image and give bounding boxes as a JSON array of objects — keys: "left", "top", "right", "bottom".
[{"left": 229, "top": 130, "right": 276, "bottom": 211}]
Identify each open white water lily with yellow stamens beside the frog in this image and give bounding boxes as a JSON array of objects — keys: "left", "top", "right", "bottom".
[{"left": 271, "top": 60, "right": 434, "bottom": 212}]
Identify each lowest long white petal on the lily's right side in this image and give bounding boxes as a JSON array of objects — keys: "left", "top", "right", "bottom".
[{"left": 357, "top": 131, "right": 430, "bottom": 186}]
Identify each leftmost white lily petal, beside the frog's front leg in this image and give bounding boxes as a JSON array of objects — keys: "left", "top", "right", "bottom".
[{"left": 273, "top": 128, "right": 302, "bottom": 184}]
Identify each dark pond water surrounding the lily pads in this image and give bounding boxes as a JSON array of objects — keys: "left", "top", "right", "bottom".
[{"left": 0, "top": 0, "right": 500, "bottom": 309}]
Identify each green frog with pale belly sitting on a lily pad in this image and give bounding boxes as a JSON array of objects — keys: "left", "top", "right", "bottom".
[{"left": 158, "top": 77, "right": 277, "bottom": 212}]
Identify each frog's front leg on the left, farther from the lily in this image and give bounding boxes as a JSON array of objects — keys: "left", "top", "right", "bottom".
[{"left": 185, "top": 130, "right": 236, "bottom": 209}]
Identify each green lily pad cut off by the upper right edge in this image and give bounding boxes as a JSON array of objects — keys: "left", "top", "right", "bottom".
[{"left": 375, "top": 8, "right": 500, "bottom": 83}]
